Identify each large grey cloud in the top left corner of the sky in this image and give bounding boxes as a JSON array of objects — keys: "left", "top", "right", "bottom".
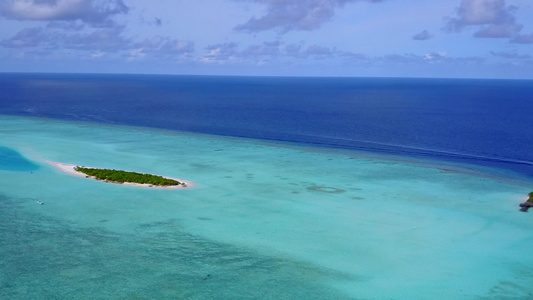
[{"left": 0, "top": 0, "right": 129, "bottom": 26}]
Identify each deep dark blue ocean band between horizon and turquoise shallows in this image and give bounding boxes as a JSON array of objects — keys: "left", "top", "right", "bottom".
[{"left": 0, "top": 73, "right": 533, "bottom": 177}]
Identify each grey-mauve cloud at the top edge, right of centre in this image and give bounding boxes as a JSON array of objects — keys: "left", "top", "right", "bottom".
[{"left": 235, "top": 0, "right": 383, "bottom": 33}]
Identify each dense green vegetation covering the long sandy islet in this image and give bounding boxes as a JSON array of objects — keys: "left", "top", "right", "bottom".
[{"left": 75, "top": 166, "right": 186, "bottom": 186}]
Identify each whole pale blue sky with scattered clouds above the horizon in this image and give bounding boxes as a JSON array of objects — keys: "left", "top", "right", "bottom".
[{"left": 0, "top": 0, "right": 533, "bottom": 79}]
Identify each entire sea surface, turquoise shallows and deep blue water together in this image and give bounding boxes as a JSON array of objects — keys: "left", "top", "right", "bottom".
[{"left": 0, "top": 73, "right": 533, "bottom": 299}]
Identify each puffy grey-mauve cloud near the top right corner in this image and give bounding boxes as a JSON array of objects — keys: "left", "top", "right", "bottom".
[{"left": 445, "top": 0, "right": 523, "bottom": 38}]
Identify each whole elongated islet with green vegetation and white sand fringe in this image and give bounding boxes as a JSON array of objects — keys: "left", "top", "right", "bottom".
[{"left": 46, "top": 161, "right": 192, "bottom": 189}]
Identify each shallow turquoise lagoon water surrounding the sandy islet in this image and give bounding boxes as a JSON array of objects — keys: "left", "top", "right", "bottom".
[{"left": 0, "top": 116, "right": 533, "bottom": 299}]
